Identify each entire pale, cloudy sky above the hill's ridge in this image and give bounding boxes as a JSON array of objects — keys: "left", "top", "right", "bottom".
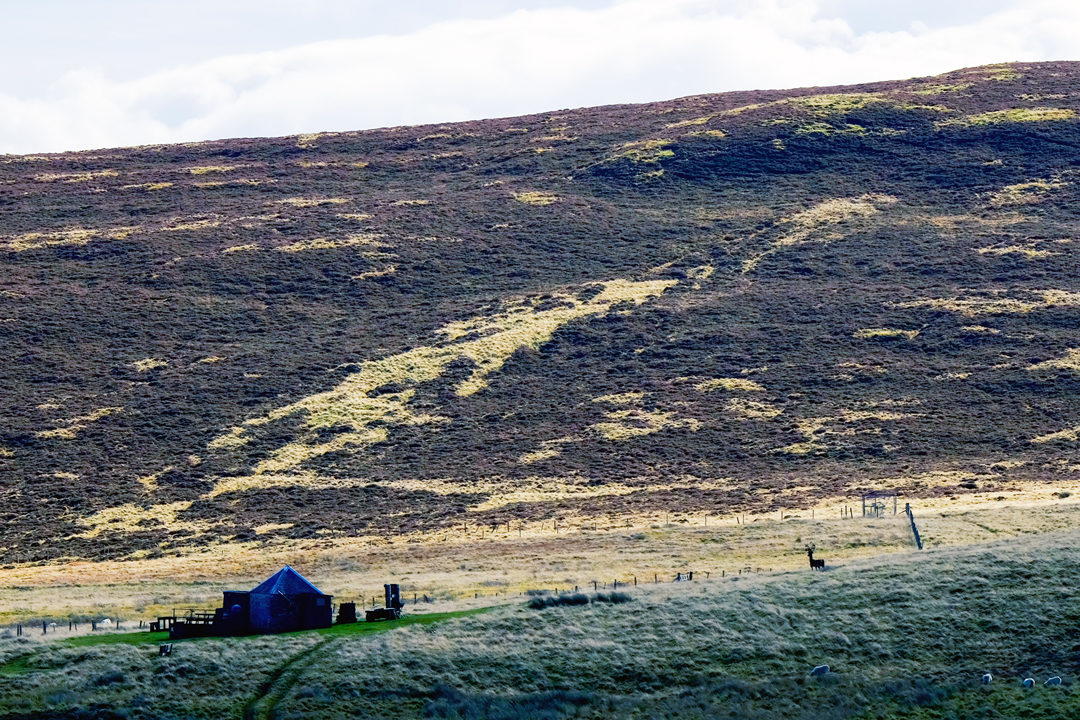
[{"left": 0, "top": 0, "right": 1080, "bottom": 153}]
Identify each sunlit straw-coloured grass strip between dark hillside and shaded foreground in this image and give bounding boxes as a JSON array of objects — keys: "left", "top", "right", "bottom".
[{"left": 0, "top": 490, "right": 1080, "bottom": 627}]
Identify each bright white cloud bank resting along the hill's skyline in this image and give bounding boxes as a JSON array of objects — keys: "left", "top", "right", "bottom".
[{"left": 0, "top": 0, "right": 1080, "bottom": 152}]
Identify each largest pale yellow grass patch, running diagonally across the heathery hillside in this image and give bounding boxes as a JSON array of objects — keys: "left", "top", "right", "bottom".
[{"left": 211, "top": 280, "right": 676, "bottom": 475}]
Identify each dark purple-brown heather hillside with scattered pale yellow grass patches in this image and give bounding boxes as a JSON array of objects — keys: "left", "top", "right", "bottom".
[{"left": 0, "top": 63, "right": 1080, "bottom": 563}]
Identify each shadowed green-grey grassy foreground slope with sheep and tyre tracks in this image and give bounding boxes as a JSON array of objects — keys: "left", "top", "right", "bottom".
[{"left": 0, "top": 530, "right": 1080, "bottom": 719}]
